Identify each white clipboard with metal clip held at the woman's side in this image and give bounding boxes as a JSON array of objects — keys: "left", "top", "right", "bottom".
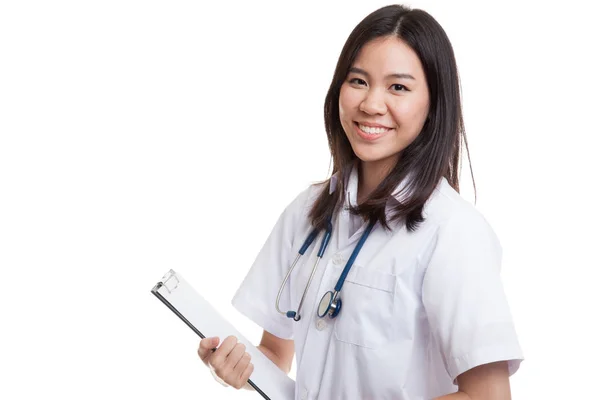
[{"left": 151, "top": 270, "right": 296, "bottom": 400}]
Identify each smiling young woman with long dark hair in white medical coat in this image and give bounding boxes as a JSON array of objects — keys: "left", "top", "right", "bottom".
[{"left": 198, "top": 6, "right": 522, "bottom": 400}]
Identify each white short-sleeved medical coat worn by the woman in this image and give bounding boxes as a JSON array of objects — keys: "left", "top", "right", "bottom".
[{"left": 233, "top": 169, "right": 523, "bottom": 400}]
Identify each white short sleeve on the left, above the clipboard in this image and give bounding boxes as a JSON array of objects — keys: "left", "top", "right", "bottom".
[{"left": 232, "top": 188, "right": 310, "bottom": 339}]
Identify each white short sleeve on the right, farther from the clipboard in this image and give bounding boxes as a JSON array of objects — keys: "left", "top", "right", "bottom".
[{"left": 422, "top": 209, "right": 523, "bottom": 384}]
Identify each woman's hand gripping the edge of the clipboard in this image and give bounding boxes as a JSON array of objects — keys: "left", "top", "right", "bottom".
[{"left": 198, "top": 336, "right": 254, "bottom": 389}]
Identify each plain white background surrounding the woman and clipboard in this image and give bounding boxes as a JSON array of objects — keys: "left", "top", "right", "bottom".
[{"left": 0, "top": 0, "right": 600, "bottom": 400}]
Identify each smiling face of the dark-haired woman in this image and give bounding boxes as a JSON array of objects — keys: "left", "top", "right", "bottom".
[{"left": 339, "top": 36, "right": 429, "bottom": 171}]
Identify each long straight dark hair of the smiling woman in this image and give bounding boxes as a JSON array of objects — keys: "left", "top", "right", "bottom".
[{"left": 310, "top": 5, "right": 475, "bottom": 231}]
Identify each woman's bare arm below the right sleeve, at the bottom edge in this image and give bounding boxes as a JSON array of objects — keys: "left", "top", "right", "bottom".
[{"left": 434, "top": 361, "right": 511, "bottom": 400}]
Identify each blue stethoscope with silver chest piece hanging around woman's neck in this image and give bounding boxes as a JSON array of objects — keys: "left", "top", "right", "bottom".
[{"left": 275, "top": 219, "right": 375, "bottom": 321}]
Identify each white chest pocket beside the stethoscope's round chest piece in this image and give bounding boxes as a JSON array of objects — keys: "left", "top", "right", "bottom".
[{"left": 333, "top": 265, "right": 396, "bottom": 349}]
